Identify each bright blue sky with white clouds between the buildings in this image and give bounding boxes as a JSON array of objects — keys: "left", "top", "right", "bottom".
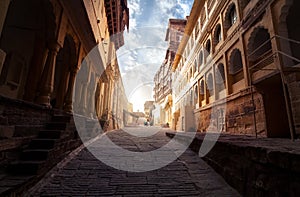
[{"left": 117, "top": 0, "right": 193, "bottom": 111}]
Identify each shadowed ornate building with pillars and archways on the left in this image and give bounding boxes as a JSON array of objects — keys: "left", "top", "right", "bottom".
[{"left": 0, "top": 0, "right": 129, "bottom": 175}]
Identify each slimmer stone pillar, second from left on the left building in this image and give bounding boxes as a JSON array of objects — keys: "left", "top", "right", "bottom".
[{"left": 64, "top": 68, "right": 78, "bottom": 113}]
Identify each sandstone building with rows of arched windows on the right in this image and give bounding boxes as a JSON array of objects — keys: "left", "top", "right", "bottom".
[{"left": 173, "top": 0, "right": 300, "bottom": 138}]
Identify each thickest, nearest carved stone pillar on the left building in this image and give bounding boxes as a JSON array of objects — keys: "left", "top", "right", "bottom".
[{"left": 37, "top": 43, "right": 60, "bottom": 106}]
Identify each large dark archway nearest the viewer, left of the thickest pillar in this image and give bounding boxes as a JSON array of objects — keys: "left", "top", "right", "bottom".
[{"left": 0, "top": 0, "right": 57, "bottom": 102}]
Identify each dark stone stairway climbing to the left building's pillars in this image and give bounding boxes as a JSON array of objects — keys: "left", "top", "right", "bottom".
[{"left": 8, "top": 115, "right": 71, "bottom": 175}]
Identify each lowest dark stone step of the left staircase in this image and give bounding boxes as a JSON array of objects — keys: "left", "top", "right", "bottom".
[{"left": 7, "top": 161, "right": 45, "bottom": 175}]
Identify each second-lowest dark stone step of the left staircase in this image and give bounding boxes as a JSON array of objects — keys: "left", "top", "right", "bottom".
[{"left": 20, "top": 149, "right": 50, "bottom": 161}]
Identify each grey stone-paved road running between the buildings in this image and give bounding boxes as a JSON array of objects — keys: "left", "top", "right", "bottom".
[{"left": 27, "top": 127, "right": 239, "bottom": 197}]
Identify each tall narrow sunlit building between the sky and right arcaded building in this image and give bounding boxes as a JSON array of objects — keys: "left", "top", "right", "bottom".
[{"left": 153, "top": 19, "right": 186, "bottom": 125}]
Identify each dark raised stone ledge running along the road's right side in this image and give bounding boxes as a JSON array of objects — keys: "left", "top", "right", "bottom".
[{"left": 166, "top": 132, "right": 300, "bottom": 196}]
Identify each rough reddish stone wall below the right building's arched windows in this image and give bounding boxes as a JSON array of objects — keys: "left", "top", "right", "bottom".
[{"left": 195, "top": 89, "right": 266, "bottom": 136}]
